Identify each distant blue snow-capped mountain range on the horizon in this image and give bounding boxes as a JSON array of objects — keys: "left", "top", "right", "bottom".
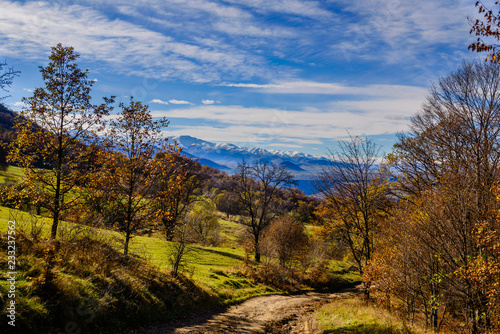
[{"left": 170, "top": 136, "right": 330, "bottom": 193}]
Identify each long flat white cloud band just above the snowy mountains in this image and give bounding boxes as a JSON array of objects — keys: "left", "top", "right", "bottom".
[{"left": 154, "top": 85, "right": 427, "bottom": 145}]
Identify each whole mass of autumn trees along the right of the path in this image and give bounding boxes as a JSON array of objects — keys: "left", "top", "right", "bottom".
[{"left": 317, "top": 63, "right": 500, "bottom": 333}]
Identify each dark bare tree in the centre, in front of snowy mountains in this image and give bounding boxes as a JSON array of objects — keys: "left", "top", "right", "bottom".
[{"left": 236, "top": 160, "right": 294, "bottom": 262}]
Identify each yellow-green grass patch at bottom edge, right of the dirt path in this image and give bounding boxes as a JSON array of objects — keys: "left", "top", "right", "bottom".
[{"left": 314, "top": 297, "right": 430, "bottom": 334}]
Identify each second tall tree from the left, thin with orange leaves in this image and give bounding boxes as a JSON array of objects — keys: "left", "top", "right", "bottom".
[{"left": 94, "top": 98, "right": 175, "bottom": 255}]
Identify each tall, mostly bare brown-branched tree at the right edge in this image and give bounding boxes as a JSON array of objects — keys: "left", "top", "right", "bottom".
[{"left": 382, "top": 63, "right": 500, "bottom": 333}]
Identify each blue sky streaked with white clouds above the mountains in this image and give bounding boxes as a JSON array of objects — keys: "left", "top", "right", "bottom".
[{"left": 0, "top": 0, "right": 487, "bottom": 156}]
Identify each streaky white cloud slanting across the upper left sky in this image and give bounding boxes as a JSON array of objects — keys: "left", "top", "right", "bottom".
[{"left": 0, "top": 1, "right": 270, "bottom": 82}]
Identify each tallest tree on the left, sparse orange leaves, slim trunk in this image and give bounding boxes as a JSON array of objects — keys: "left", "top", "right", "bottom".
[{"left": 9, "top": 44, "right": 113, "bottom": 238}]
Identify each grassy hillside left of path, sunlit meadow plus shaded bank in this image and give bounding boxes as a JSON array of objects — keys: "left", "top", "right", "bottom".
[{"left": 0, "top": 200, "right": 359, "bottom": 332}]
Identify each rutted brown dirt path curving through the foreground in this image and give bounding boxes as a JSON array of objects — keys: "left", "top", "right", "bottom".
[{"left": 119, "top": 289, "right": 357, "bottom": 334}]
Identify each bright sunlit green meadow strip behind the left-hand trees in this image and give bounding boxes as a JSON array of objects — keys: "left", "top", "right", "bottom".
[{"left": 0, "top": 207, "right": 282, "bottom": 304}]
